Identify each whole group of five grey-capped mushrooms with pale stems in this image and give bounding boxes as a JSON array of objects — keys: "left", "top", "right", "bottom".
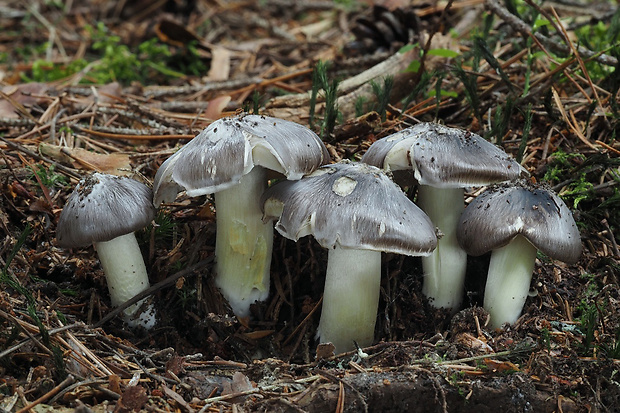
[{"left": 57, "top": 114, "right": 581, "bottom": 352}]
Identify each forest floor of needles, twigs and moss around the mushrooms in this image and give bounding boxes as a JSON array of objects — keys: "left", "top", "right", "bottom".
[{"left": 0, "top": 0, "right": 620, "bottom": 413}]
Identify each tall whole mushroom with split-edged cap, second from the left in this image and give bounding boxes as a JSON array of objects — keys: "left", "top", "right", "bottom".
[{"left": 153, "top": 115, "right": 329, "bottom": 317}]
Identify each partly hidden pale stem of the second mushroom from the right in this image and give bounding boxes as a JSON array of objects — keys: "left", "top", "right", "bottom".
[{"left": 418, "top": 185, "right": 467, "bottom": 311}]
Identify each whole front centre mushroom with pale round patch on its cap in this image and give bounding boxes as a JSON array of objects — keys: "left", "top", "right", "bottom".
[{"left": 262, "top": 163, "right": 437, "bottom": 352}]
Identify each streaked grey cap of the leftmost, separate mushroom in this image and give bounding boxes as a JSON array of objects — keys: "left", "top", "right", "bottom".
[{"left": 56, "top": 173, "right": 155, "bottom": 248}]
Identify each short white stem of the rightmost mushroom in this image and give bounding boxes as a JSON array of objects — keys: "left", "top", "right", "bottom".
[{"left": 484, "top": 235, "right": 538, "bottom": 328}]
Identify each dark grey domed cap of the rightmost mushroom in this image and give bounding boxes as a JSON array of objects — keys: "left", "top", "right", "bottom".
[{"left": 457, "top": 181, "right": 582, "bottom": 264}]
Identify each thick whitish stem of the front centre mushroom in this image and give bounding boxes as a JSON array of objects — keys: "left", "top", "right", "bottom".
[{"left": 317, "top": 246, "right": 381, "bottom": 354}]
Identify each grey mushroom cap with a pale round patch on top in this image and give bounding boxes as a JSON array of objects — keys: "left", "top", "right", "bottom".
[{"left": 261, "top": 163, "right": 437, "bottom": 255}]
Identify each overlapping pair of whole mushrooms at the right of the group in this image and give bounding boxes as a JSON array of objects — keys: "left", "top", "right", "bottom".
[{"left": 362, "top": 123, "right": 581, "bottom": 327}]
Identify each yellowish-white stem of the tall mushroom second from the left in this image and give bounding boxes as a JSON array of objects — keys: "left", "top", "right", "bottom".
[{"left": 215, "top": 166, "right": 273, "bottom": 317}]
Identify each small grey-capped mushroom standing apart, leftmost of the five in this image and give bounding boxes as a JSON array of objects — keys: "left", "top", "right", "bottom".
[{"left": 56, "top": 173, "right": 156, "bottom": 329}]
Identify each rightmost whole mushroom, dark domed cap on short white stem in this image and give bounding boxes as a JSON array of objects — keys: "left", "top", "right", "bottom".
[{"left": 457, "top": 181, "right": 581, "bottom": 328}]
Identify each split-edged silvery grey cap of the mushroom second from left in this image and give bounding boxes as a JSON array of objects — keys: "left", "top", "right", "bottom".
[{"left": 153, "top": 114, "right": 330, "bottom": 206}]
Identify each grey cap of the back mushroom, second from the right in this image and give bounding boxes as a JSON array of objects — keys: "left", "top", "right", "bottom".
[{"left": 362, "top": 123, "right": 526, "bottom": 188}]
